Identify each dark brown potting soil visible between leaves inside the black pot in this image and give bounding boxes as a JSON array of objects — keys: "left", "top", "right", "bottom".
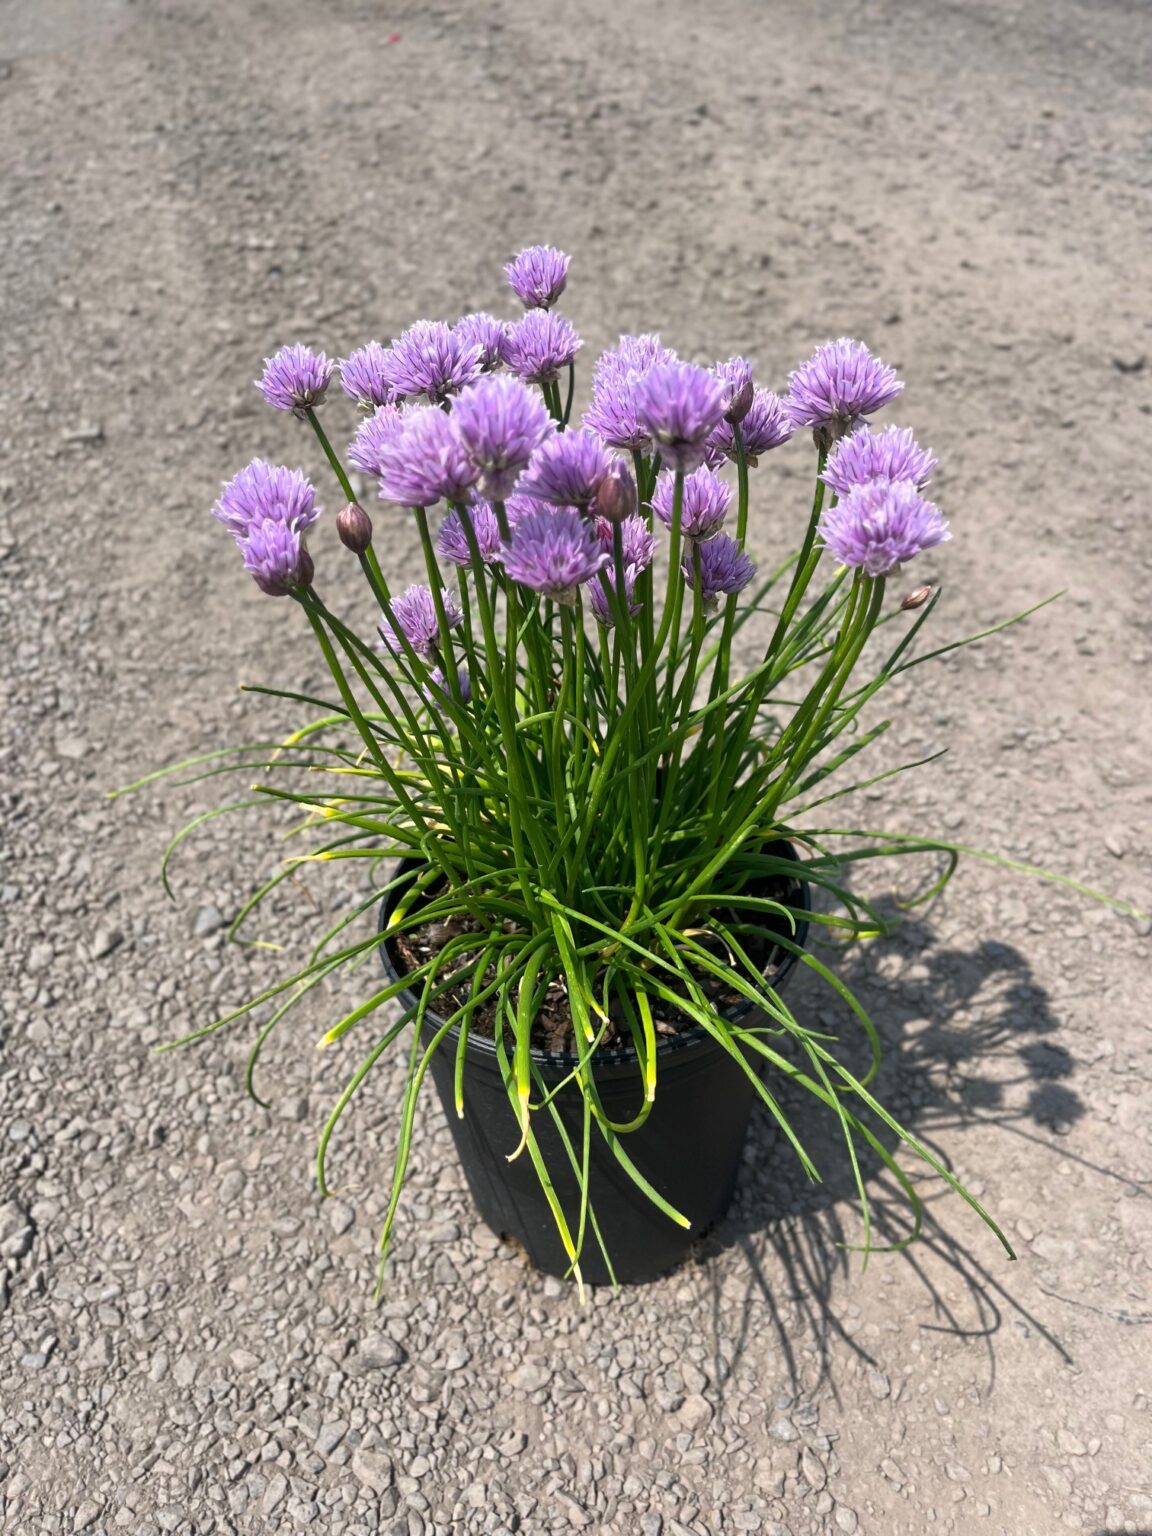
[{"left": 389, "top": 880, "right": 794, "bottom": 1055}]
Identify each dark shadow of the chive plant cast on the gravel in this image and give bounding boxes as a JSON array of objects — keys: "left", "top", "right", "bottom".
[{"left": 700, "top": 897, "right": 1148, "bottom": 1392}]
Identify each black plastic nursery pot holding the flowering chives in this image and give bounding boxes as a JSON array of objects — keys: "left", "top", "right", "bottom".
[{"left": 381, "top": 840, "right": 808, "bottom": 1286}]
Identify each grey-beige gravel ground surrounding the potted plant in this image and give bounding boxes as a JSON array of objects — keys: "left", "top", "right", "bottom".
[{"left": 0, "top": 0, "right": 1152, "bottom": 1536}]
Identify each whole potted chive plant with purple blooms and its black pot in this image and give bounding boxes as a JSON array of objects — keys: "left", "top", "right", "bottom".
[{"left": 130, "top": 247, "right": 1142, "bottom": 1284}]
